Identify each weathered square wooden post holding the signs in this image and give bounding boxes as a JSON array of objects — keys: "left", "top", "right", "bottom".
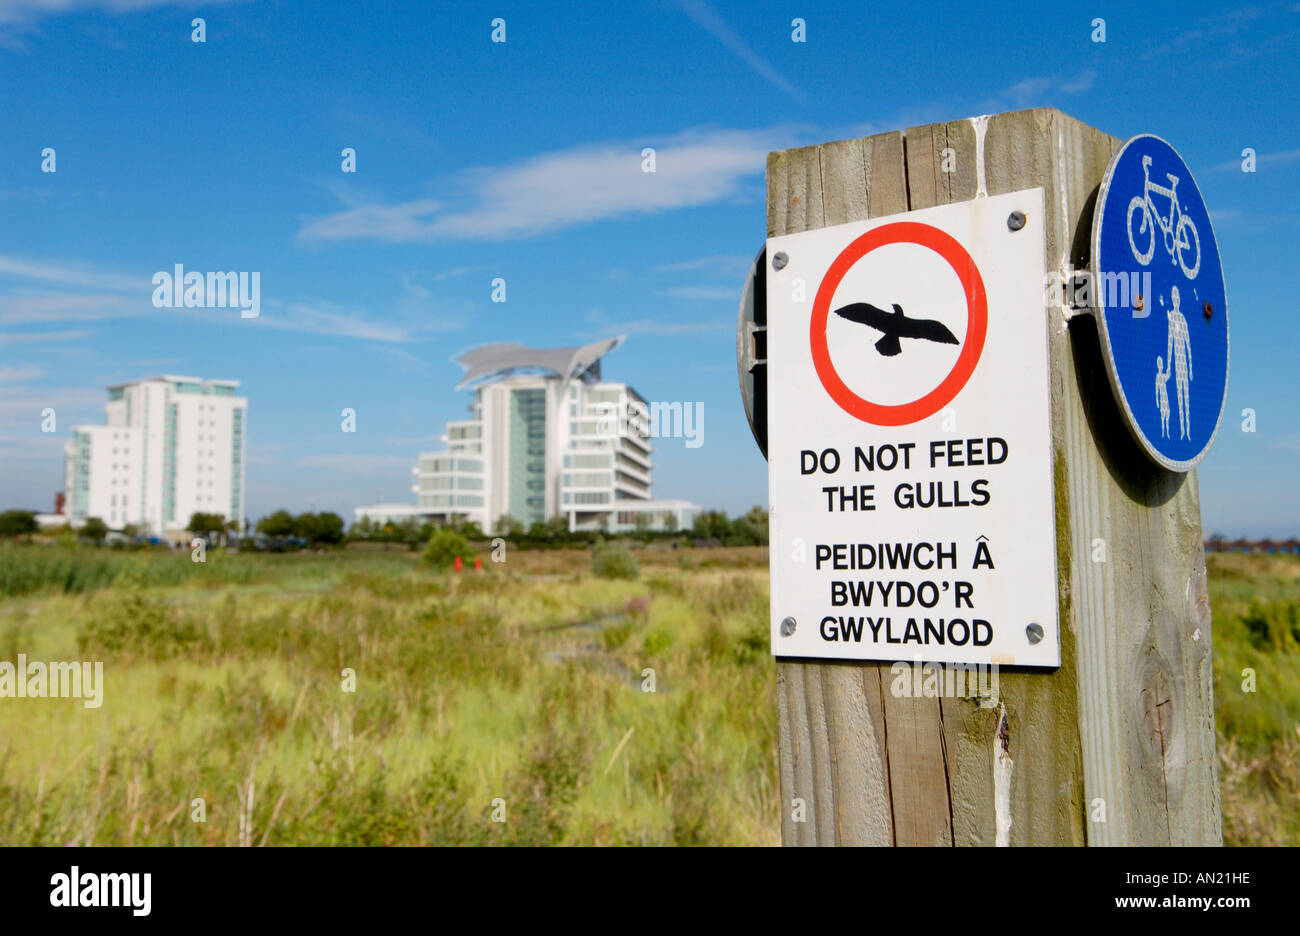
[{"left": 767, "top": 109, "right": 1222, "bottom": 845}]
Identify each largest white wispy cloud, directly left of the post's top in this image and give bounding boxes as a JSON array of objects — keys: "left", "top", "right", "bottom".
[{"left": 298, "top": 127, "right": 796, "bottom": 243}]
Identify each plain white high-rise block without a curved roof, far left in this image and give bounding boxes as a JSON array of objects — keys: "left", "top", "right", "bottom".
[{"left": 64, "top": 376, "right": 248, "bottom": 536}]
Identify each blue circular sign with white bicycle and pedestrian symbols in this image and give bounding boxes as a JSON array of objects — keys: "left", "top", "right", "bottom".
[{"left": 1089, "top": 134, "right": 1227, "bottom": 471}]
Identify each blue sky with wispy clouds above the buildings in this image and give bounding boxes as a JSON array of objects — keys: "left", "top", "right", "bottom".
[{"left": 0, "top": 0, "right": 1300, "bottom": 536}]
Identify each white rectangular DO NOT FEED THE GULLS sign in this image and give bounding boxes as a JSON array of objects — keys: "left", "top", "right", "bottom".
[{"left": 767, "top": 189, "right": 1061, "bottom": 667}]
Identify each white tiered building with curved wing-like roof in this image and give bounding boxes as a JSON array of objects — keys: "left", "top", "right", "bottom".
[{"left": 355, "top": 338, "right": 699, "bottom": 532}]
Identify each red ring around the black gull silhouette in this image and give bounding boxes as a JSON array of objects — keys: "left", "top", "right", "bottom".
[{"left": 809, "top": 221, "right": 988, "bottom": 425}]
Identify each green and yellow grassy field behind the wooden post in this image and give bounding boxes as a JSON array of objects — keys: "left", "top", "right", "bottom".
[{"left": 0, "top": 546, "right": 1300, "bottom": 845}]
